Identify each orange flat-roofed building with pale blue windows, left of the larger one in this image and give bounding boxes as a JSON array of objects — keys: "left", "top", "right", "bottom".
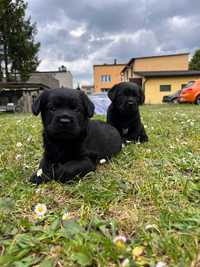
[{"left": 93, "top": 60, "right": 126, "bottom": 93}]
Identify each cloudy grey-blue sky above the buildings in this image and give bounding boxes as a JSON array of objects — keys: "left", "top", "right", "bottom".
[{"left": 28, "top": 0, "right": 200, "bottom": 87}]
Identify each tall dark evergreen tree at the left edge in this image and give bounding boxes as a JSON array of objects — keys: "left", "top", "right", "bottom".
[{"left": 0, "top": 0, "right": 40, "bottom": 81}]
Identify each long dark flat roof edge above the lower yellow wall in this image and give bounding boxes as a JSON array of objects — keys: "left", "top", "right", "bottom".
[{"left": 135, "top": 70, "right": 200, "bottom": 77}]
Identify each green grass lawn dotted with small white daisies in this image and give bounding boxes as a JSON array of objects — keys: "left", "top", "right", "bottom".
[{"left": 0, "top": 105, "right": 200, "bottom": 267}]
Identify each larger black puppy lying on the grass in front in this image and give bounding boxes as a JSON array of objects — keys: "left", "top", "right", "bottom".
[{"left": 31, "top": 88, "right": 122, "bottom": 184}]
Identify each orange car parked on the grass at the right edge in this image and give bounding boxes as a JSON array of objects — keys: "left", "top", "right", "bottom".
[{"left": 178, "top": 80, "right": 200, "bottom": 105}]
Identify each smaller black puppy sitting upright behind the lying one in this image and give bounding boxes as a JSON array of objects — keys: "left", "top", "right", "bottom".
[{"left": 107, "top": 82, "right": 148, "bottom": 142}]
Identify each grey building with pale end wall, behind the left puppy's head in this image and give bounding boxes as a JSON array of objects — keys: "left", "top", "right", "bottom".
[{"left": 27, "top": 68, "right": 73, "bottom": 88}]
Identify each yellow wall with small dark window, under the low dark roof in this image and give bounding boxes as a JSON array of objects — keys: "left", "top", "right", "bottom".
[{"left": 143, "top": 76, "right": 200, "bottom": 104}]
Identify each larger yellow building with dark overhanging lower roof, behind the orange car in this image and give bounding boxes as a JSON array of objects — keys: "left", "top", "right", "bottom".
[{"left": 121, "top": 53, "right": 200, "bottom": 104}]
